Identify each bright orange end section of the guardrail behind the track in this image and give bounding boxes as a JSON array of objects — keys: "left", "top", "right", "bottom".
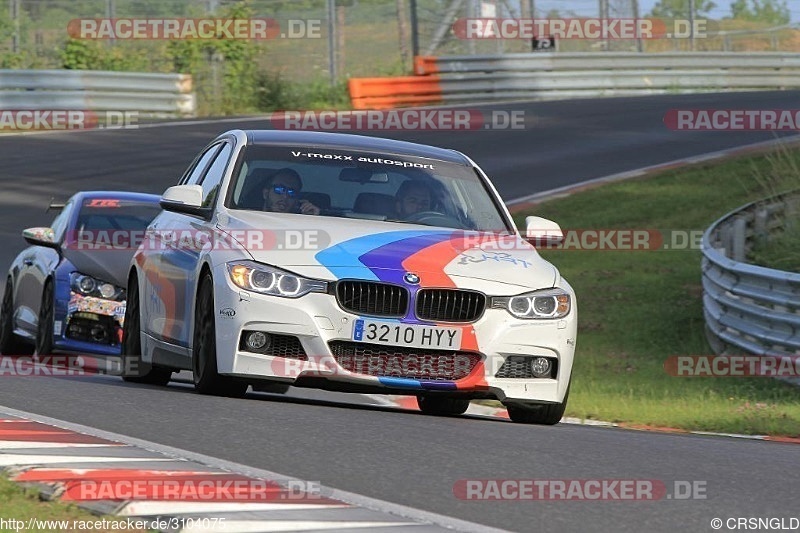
[{"left": 348, "top": 64, "right": 442, "bottom": 109}]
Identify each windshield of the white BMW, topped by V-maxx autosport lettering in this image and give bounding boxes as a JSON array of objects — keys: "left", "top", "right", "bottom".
[{"left": 226, "top": 145, "right": 509, "bottom": 232}]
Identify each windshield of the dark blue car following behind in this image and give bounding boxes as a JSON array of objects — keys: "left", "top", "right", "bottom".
[{"left": 75, "top": 198, "right": 161, "bottom": 232}]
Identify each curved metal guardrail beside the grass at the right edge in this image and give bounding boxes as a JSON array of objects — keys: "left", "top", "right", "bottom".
[{"left": 701, "top": 192, "right": 800, "bottom": 356}]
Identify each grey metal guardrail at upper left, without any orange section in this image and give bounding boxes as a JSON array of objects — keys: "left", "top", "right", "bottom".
[{"left": 0, "top": 70, "right": 197, "bottom": 116}]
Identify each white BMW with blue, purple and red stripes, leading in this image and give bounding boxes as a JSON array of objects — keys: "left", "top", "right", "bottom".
[{"left": 122, "top": 131, "right": 577, "bottom": 424}]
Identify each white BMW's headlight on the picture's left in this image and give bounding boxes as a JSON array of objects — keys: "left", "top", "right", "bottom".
[{"left": 227, "top": 261, "right": 328, "bottom": 298}]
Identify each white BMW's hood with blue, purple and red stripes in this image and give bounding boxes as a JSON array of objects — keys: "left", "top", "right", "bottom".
[{"left": 220, "top": 211, "right": 559, "bottom": 295}]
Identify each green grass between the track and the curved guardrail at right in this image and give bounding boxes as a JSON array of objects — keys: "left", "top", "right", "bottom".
[{"left": 515, "top": 151, "right": 800, "bottom": 436}]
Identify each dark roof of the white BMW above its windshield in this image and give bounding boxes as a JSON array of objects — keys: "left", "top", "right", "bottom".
[{"left": 245, "top": 130, "right": 471, "bottom": 166}]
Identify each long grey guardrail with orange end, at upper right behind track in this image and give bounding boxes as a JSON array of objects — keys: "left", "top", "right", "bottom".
[{"left": 350, "top": 52, "right": 800, "bottom": 109}]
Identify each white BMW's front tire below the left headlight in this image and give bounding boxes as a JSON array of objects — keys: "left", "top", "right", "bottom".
[{"left": 192, "top": 272, "right": 247, "bottom": 398}]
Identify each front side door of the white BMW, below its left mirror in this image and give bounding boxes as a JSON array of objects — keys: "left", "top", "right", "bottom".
[{"left": 137, "top": 143, "right": 222, "bottom": 344}]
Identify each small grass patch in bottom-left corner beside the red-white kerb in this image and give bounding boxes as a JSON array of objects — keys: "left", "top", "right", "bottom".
[{"left": 0, "top": 475, "right": 147, "bottom": 533}]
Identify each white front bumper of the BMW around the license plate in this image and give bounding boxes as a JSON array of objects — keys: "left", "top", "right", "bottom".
[{"left": 215, "top": 264, "right": 577, "bottom": 403}]
